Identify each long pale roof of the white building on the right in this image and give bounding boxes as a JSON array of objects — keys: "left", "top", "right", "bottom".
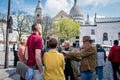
[{"left": 95, "top": 17, "right": 120, "bottom": 23}]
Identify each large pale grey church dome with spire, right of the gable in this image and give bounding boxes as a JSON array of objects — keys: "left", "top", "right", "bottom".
[{"left": 70, "top": 0, "right": 83, "bottom": 17}]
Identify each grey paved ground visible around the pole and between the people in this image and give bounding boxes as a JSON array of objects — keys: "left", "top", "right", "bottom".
[{"left": 0, "top": 52, "right": 120, "bottom": 80}]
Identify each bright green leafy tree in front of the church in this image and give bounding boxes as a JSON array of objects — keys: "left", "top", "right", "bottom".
[{"left": 53, "top": 18, "right": 80, "bottom": 40}]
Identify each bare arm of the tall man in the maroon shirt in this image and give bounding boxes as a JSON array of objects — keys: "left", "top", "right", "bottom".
[{"left": 35, "top": 49, "right": 42, "bottom": 73}]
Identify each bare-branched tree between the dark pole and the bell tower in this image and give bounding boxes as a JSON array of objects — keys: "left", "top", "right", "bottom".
[{"left": 13, "top": 11, "right": 33, "bottom": 41}]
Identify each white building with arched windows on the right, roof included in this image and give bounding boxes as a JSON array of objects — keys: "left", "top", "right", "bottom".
[{"left": 79, "top": 16, "right": 120, "bottom": 45}]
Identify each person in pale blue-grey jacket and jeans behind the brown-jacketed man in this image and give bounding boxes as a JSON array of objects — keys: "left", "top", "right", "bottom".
[{"left": 96, "top": 44, "right": 106, "bottom": 80}]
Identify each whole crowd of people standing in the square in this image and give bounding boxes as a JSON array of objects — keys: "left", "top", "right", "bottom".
[{"left": 13, "top": 23, "right": 120, "bottom": 80}]
